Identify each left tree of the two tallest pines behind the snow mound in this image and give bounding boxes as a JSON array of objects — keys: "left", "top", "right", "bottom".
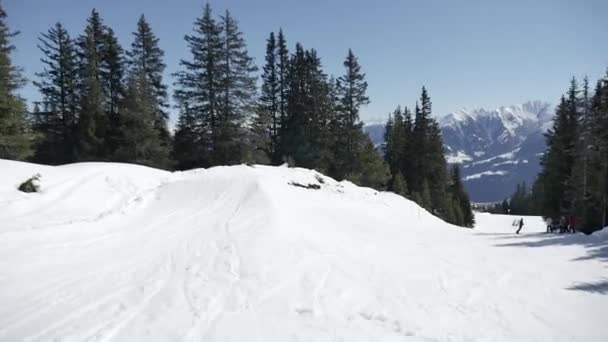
[{"left": 173, "top": 3, "right": 223, "bottom": 168}]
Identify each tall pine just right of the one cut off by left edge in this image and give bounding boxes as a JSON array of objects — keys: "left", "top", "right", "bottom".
[{"left": 34, "top": 23, "right": 79, "bottom": 164}]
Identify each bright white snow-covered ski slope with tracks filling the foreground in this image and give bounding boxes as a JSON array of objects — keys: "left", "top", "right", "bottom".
[{"left": 0, "top": 160, "right": 608, "bottom": 341}]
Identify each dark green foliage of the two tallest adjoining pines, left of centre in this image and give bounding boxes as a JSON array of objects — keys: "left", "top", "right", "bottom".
[{"left": 174, "top": 4, "right": 257, "bottom": 168}]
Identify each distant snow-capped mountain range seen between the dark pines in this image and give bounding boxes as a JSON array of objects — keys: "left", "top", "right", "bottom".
[{"left": 367, "top": 101, "right": 554, "bottom": 202}]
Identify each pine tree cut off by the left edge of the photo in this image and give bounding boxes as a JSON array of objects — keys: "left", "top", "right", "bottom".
[{"left": 0, "top": 4, "right": 31, "bottom": 159}]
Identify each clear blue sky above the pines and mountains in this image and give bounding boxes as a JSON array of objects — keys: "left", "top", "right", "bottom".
[{"left": 0, "top": 0, "right": 608, "bottom": 120}]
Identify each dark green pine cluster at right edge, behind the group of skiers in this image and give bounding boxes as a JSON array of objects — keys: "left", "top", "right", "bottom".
[{"left": 531, "top": 76, "right": 608, "bottom": 232}]
